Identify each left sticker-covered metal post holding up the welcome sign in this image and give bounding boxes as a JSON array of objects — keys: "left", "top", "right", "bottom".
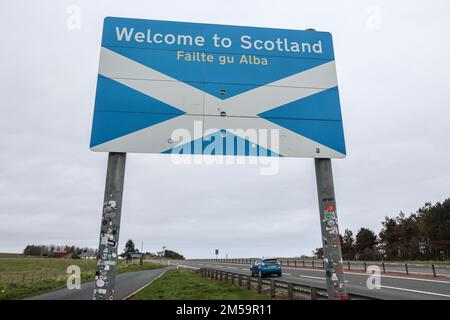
[{"left": 93, "top": 152, "right": 126, "bottom": 300}]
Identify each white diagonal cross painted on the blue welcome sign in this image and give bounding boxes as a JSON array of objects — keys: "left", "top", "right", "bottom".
[{"left": 93, "top": 47, "right": 344, "bottom": 157}]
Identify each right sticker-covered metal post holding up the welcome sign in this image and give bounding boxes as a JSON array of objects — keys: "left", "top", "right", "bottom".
[{"left": 314, "top": 158, "right": 348, "bottom": 300}]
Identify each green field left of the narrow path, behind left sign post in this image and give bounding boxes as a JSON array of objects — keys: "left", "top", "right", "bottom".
[{"left": 0, "top": 254, "right": 164, "bottom": 300}]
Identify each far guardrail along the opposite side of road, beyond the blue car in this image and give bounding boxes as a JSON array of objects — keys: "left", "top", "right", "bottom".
[{"left": 191, "top": 258, "right": 450, "bottom": 277}]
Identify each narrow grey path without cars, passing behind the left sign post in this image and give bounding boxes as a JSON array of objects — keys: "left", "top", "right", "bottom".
[{"left": 26, "top": 267, "right": 170, "bottom": 300}]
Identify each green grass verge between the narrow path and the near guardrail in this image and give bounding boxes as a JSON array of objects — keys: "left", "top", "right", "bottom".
[{"left": 132, "top": 270, "right": 270, "bottom": 300}]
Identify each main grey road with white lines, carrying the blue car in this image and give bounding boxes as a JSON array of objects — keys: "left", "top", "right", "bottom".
[{"left": 172, "top": 261, "right": 450, "bottom": 300}]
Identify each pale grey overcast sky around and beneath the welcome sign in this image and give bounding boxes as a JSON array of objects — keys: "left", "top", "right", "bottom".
[{"left": 0, "top": 0, "right": 450, "bottom": 258}]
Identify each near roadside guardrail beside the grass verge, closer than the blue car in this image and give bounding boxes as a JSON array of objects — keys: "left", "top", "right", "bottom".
[{"left": 198, "top": 268, "right": 374, "bottom": 300}]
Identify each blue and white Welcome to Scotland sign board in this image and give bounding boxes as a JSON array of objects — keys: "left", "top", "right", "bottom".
[{"left": 91, "top": 17, "right": 346, "bottom": 158}]
